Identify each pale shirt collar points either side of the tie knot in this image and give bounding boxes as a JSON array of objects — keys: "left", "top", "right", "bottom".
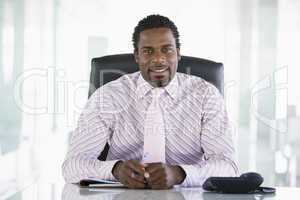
[{"left": 137, "top": 73, "right": 178, "bottom": 99}]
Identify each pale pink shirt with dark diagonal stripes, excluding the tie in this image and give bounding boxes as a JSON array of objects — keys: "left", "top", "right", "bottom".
[{"left": 63, "top": 72, "right": 238, "bottom": 186}]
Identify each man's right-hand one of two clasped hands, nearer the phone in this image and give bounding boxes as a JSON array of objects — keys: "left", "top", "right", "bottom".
[{"left": 146, "top": 163, "right": 186, "bottom": 189}]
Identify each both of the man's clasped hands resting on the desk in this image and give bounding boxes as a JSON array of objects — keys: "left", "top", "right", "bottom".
[{"left": 113, "top": 160, "right": 185, "bottom": 189}]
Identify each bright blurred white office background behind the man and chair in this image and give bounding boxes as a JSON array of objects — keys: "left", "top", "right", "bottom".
[{"left": 0, "top": 0, "right": 300, "bottom": 199}]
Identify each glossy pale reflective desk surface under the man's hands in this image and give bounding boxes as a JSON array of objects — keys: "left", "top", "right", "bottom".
[{"left": 4, "top": 184, "right": 300, "bottom": 200}]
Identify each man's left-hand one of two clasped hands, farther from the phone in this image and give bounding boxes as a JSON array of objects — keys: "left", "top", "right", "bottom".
[{"left": 112, "top": 160, "right": 146, "bottom": 189}]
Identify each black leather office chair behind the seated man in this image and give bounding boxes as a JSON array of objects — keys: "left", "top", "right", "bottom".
[{"left": 89, "top": 54, "right": 224, "bottom": 160}]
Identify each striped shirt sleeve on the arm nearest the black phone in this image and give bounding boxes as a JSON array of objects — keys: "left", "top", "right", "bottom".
[{"left": 180, "top": 83, "right": 239, "bottom": 187}]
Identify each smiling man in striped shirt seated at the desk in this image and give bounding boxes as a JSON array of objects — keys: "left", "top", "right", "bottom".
[{"left": 63, "top": 15, "right": 238, "bottom": 189}]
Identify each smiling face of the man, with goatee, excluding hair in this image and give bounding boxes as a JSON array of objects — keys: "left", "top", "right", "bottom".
[{"left": 135, "top": 28, "right": 180, "bottom": 87}]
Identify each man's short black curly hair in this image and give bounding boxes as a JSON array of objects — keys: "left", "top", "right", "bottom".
[{"left": 132, "top": 15, "right": 180, "bottom": 52}]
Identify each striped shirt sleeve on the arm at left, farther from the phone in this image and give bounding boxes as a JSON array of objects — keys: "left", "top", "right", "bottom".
[{"left": 62, "top": 87, "right": 118, "bottom": 183}]
